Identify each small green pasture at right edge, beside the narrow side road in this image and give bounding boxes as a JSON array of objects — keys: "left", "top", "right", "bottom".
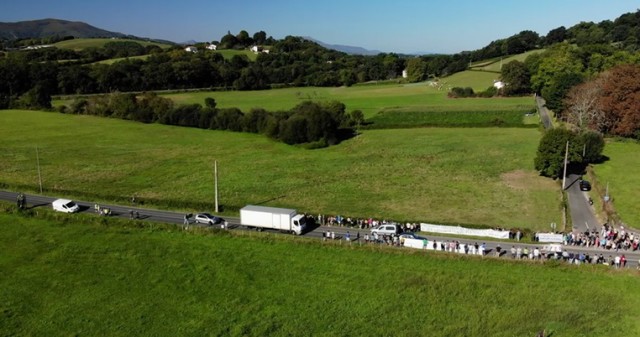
[{"left": 593, "top": 140, "right": 640, "bottom": 228}]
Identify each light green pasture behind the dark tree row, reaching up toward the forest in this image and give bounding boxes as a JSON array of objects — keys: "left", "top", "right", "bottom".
[{"left": 163, "top": 71, "right": 535, "bottom": 118}]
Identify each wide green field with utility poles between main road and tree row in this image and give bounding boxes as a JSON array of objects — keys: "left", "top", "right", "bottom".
[{"left": 0, "top": 110, "right": 560, "bottom": 229}]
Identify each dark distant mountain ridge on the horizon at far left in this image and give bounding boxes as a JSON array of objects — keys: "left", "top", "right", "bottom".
[{"left": 0, "top": 19, "right": 126, "bottom": 40}]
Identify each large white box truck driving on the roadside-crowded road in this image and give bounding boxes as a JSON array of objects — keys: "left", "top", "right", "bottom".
[{"left": 240, "top": 205, "right": 307, "bottom": 235}]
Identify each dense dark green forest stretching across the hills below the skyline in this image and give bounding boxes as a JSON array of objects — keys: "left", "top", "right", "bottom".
[{"left": 0, "top": 11, "right": 640, "bottom": 142}]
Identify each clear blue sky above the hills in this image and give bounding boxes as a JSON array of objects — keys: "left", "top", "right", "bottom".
[{"left": 0, "top": 0, "right": 640, "bottom": 53}]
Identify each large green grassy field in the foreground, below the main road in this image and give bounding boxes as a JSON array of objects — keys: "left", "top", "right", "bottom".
[{"left": 0, "top": 212, "right": 640, "bottom": 337}]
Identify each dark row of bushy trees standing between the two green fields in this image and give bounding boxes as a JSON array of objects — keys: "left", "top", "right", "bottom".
[{"left": 67, "top": 93, "right": 363, "bottom": 148}]
